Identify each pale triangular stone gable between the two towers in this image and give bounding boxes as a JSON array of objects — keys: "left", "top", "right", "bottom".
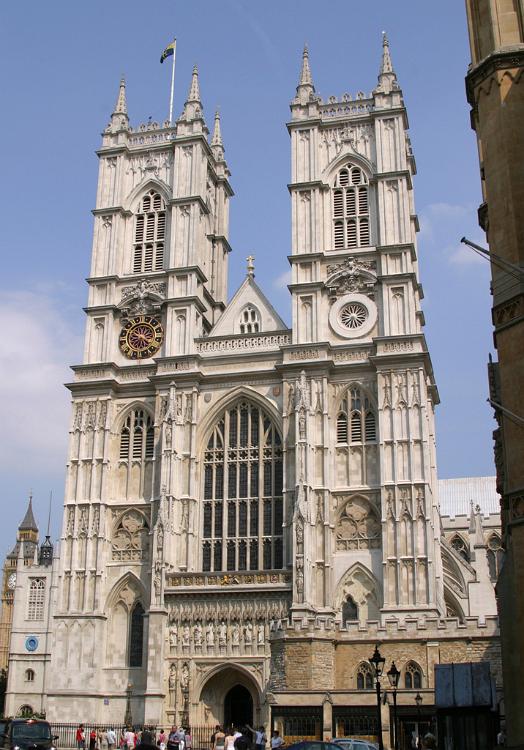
[{"left": 209, "top": 274, "right": 288, "bottom": 337}]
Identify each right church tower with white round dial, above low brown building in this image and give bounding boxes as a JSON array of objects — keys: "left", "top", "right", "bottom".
[{"left": 288, "top": 34, "right": 446, "bottom": 620}]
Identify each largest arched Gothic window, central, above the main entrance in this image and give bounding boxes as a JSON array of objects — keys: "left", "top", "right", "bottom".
[{"left": 202, "top": 401, "right": 283, "bottom": 571}]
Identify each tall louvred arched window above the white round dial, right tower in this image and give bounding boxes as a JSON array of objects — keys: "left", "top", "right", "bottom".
[{"left": 332, "top": 164, "right": 370, "bottom": 250}]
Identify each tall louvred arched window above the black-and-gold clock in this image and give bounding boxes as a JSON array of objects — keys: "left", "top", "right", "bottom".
[{"left": 133, "top": 190, "right": 166, "bottom": 273}]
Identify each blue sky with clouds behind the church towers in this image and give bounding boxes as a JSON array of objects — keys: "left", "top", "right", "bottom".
[{"left": 0, "top": 0, "right": 494, "bottom": 556}]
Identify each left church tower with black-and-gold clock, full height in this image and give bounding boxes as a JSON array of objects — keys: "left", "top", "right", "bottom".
[{"left": 47, "top": 67, "right": 232, "bottom": 723}]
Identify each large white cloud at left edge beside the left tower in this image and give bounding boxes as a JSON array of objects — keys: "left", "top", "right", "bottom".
[{"left": 0, "top": 287, "right": 81, "bottom": 472}]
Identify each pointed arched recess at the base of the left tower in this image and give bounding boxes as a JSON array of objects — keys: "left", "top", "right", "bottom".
[{"left": 105, "top": 573, "right": 146, "bottom": 667}]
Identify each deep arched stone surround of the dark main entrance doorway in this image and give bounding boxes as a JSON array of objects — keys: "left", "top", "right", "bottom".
[{"left": 195, "top": 663, "right": 262, "bottom": 726}]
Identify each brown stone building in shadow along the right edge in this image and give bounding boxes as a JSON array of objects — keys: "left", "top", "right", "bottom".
[{"left": 466, "top": 0, "right": 524, "bottom": 749}]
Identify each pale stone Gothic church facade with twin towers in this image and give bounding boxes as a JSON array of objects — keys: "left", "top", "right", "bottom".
[{"left": 7, "top": 38, "right": 500, "bottom": 748}]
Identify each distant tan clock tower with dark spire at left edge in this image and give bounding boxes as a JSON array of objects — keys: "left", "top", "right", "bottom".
[{"left": 0, "top": 495, "right": 38, "bottom": 670}]
